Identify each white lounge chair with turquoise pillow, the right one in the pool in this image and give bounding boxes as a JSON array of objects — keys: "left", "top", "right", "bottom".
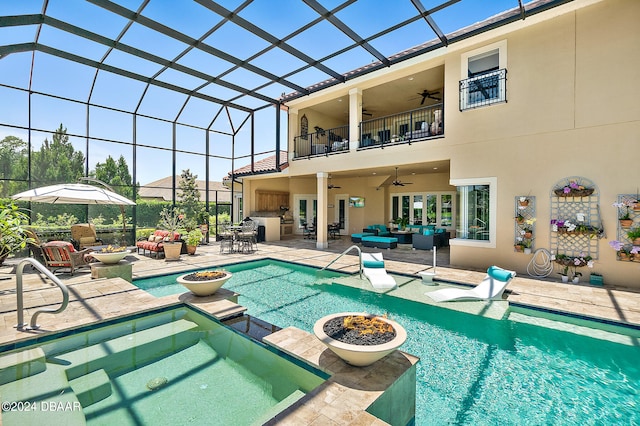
[{"left": 425, "top": 266, "right": 516, "bottom": 302}]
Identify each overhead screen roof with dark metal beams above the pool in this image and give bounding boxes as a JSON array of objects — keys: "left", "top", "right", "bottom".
[{"left": 0, "top": 0, "right": 572, "bottom": 119}]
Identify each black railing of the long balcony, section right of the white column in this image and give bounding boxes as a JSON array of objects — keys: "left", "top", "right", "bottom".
[{"left": 360, "top": 103, "right": 444, "bottom": 148}]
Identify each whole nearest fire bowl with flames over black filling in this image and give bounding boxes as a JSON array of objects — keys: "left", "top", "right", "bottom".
[{"left": 313, "top": 312, "right": 407, "bottom": 367}]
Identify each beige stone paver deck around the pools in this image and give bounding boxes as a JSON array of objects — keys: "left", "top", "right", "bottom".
[{"left": 0, "top": 237, "right": 640, "bottom": 425}]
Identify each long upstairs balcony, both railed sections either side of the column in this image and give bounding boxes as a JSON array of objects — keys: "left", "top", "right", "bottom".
[{"left": 293, "top": 103, "right": 444, "bottom": 159}]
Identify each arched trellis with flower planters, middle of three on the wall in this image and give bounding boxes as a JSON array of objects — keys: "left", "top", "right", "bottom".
[{"left": 549, "top": 176, "right": 603, "bottom": 259}]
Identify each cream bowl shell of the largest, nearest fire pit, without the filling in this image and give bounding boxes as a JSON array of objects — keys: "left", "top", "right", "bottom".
[{"left": 313, "top": 312, "right": 407, "bottom": 367}]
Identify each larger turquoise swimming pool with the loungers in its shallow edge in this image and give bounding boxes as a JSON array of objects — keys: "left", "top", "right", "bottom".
[{"left": 134, "top": 261, "right": 640, "bottom": 425}]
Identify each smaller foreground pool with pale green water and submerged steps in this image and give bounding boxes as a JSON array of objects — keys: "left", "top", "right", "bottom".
[{"left": 0, "top": 308, "right": 326, "bottom": 425}]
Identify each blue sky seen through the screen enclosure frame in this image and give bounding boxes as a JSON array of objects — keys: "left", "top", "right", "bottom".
[{"left": 0, "top": 0, "right": 518, "bottom": 185}]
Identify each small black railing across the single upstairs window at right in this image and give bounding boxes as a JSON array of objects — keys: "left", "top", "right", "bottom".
[{"left": 460, "top": 69, "right": 507, "bottom": 111}]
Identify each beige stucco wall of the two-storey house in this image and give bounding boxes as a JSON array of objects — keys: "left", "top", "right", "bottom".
[{"left": 242, "top": 0, "right": 640, "bottom": 289}]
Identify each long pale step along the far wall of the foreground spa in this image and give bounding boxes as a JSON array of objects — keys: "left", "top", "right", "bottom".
[{"left": 64, "top": 319, "right": 200, "bottom": 380}]
